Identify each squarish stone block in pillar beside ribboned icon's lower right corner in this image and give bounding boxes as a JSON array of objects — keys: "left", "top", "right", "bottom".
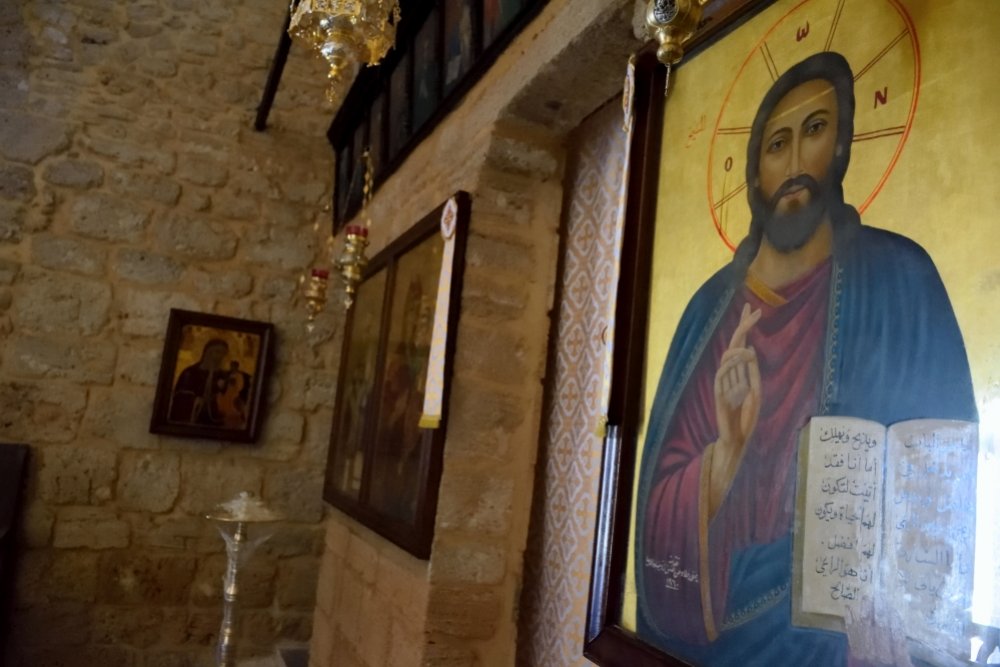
[{"left": 436, "top": 473, "right": 514, "bottom": 535}]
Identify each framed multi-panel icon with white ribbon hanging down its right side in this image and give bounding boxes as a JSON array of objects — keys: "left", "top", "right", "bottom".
[{"left": 324, "top": 193, "right": 469, "bottom": 558}]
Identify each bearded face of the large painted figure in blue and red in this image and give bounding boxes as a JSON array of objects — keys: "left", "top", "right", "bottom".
[{"left": 758, "top": 79, "right": 837, "bottom": 251}]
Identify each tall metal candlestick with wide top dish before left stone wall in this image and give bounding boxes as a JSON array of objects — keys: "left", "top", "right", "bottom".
[{"left": 206, "top": 491, "right": 284, "bottom": 667}]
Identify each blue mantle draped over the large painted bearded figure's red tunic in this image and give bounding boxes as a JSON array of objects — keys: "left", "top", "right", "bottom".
[{"left": 635, "top": 206, "right": 978, "bottom": 667}]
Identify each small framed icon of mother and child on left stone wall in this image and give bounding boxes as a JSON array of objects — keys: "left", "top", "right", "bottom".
[{"left": 149, "top": 308, "right": 274, "bottom": 442}]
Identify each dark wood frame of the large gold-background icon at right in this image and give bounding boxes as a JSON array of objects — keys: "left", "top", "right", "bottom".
[{"left": 583, "top": 0, "right": 773, "bottom": 667}]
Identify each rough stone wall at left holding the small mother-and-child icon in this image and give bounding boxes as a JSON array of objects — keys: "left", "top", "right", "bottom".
[{"left": 0, "top": 0, "right": 339, "bottom": 667}]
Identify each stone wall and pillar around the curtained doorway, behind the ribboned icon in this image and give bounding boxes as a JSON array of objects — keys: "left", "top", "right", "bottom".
[{"left": 311, "top": 0, "right": 638, "bottom": 667}]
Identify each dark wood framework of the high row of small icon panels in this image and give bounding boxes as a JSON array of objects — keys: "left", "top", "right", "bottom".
[{"left": 327, "top": 0, "right": 548, "bottom": 232}]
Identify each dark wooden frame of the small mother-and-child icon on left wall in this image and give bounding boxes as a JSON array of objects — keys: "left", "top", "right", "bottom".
[{"left": 149, "top": 308, "right": 274, "bottom": 442}]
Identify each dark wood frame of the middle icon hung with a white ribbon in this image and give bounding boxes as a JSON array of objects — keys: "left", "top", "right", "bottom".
[{"left": 323, "top": 192, "right": 470, "bottom": 558}]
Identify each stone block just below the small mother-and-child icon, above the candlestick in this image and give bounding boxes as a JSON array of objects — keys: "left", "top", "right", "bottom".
[{"left": 180, "top": 456, "right": 262, "bottom": 514}]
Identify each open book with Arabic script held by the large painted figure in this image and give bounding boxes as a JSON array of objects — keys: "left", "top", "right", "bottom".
[{"left": 792, "top": 417, "right": 978, "bottom": 657}]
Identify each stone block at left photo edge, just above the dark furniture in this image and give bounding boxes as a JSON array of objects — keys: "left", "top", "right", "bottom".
[{"left": 0, "top": 381, "right": 87, "bottom": 444}]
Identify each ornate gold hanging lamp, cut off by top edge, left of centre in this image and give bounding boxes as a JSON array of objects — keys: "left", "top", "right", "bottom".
[{"left": 288, "top": 0, "right": 400, "bottom": 105}]
